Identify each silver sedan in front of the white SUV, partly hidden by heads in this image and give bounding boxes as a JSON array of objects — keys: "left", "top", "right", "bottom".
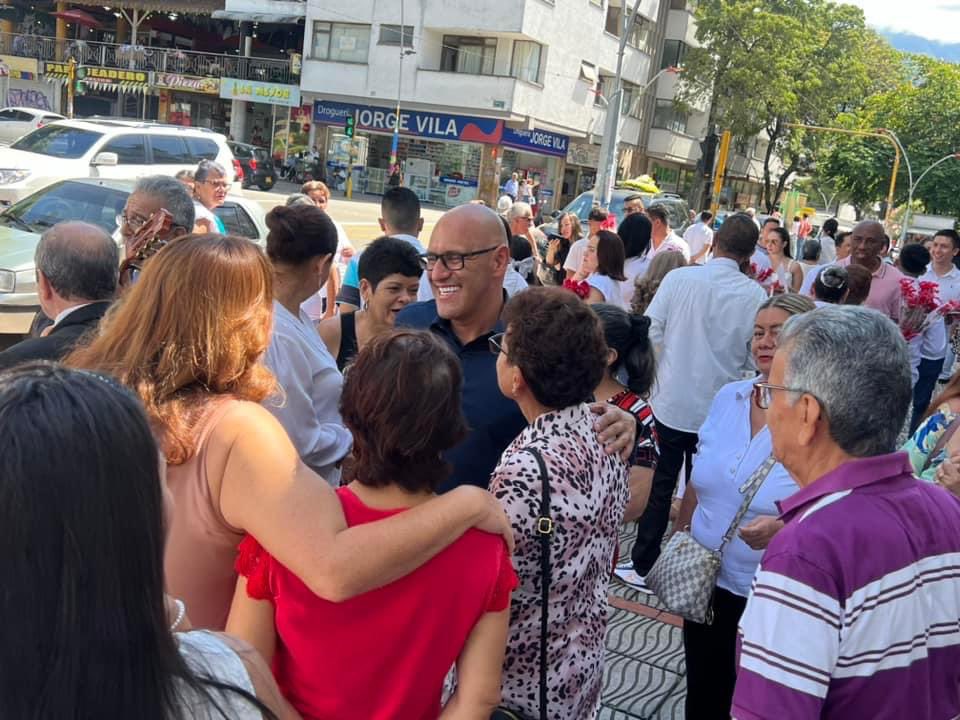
[{"left": 0, "top": 178, "right": 267, "bottom": 338}]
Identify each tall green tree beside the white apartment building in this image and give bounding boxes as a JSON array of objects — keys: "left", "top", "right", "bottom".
[{"left": 679, "top": 0, "right": 902, "bottom": 211}]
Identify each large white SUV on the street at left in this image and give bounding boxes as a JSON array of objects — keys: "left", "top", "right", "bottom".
[{"left": 0, "top": 120, "right": 243, "bottom": 205}]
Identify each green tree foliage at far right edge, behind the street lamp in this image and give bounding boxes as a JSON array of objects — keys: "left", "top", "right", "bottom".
[{"left": 820, "top": 56, "right": 960, "bottom": 216}]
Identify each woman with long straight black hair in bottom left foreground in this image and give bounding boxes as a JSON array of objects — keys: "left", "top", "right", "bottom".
[{"left": 0, "top": 363, "right": 286, "bottom": 720}]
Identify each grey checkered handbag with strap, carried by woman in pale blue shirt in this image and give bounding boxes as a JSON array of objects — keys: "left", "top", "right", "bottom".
[{"left": 646, "top": 462, "right": 776, "bottom": 625}]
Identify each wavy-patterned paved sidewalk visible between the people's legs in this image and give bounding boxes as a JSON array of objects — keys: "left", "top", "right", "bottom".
[{"left": 599, "top": 523, "right": 687, "bottom": 720}]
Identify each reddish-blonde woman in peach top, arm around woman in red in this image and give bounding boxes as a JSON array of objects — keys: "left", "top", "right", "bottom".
[{"left": 67, "top": 235, "right": 506, "bottom": 630}]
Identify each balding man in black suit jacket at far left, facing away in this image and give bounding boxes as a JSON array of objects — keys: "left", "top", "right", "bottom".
[{"left": 0, "top": 222, "right": 120, "bottom": 369}]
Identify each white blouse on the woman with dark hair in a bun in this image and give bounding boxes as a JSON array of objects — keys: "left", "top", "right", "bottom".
[{"left": 263, "top": 300, "right": 353, "bottom": 487}]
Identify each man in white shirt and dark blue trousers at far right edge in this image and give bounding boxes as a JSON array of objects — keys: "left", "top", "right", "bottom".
[{"left": 911, "top": 229, "right": 960, "bottom": 422}]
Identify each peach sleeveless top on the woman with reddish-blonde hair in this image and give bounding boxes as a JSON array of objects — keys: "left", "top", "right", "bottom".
[{"left": 164, "top": 398, "right": 244, "bottom": 630}]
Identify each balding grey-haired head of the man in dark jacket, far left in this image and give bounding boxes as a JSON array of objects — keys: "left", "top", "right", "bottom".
[{"left": 34, "top": 222, "right": 120, "bottom": 303}]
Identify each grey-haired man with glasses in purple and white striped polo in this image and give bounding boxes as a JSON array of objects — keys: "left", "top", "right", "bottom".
[{"left": 731, "top": 306, "right": 960, "bottom": 720}]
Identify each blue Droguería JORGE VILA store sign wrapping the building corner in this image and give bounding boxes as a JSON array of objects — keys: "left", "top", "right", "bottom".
[{"left": 313, "top": 100, "right": 568, "bottom": 157}]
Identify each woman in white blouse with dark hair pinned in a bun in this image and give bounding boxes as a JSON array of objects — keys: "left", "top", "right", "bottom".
[{"left": 265, "top": 205, "right": 353, "bottom": 486}]
